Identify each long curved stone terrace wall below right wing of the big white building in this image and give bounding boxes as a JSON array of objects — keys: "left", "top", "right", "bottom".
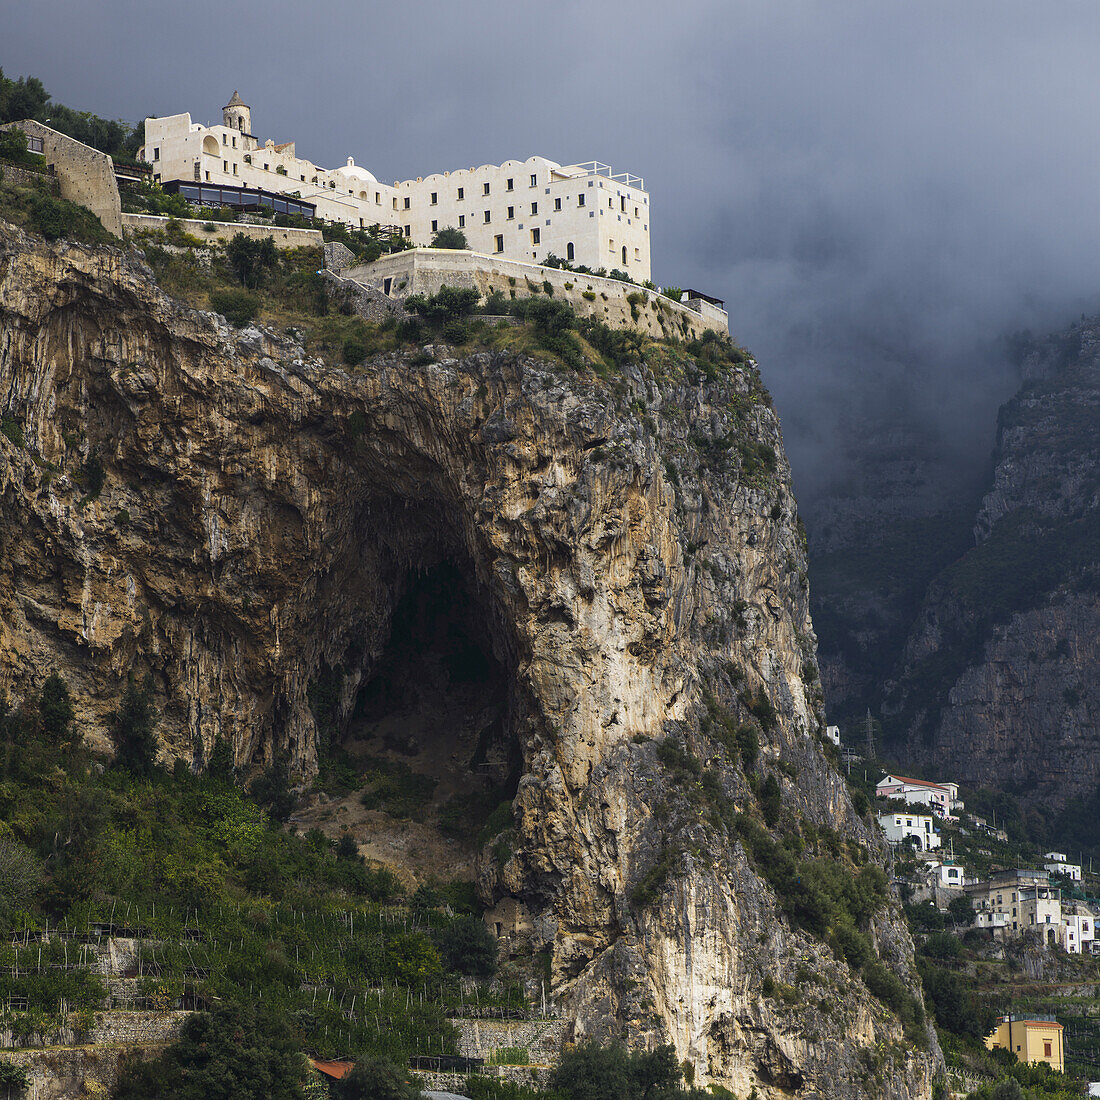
[{"left": 340, "top": 249, "right": 728, "bottom": 340}]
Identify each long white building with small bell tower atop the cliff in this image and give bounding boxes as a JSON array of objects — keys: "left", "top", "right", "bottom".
[{"left": 142, "top": 91, "right": 650, "bottom": 282}]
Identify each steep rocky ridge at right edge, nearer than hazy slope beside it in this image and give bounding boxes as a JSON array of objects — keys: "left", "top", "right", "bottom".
[{"left": 887, "top": 319, "right": 1100, "bottom": 805}]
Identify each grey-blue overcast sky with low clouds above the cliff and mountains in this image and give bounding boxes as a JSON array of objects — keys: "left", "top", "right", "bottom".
[{"left": 0, "top": 0, "right": 1100, "bottom": 495}]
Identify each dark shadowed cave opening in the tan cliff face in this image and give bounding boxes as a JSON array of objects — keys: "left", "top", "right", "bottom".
[{"left": 336, "top": 562, "right": 523, "bottom": 859}]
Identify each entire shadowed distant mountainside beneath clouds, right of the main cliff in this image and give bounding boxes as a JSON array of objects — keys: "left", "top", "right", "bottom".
[{"left": 810, "top": 318, "right": 1100, "bottom": 805}]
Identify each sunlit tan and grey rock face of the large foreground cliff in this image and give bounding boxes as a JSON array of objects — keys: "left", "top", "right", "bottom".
[{"left": 0, "top": 227, "right": 938, "bottom": 1100}]
